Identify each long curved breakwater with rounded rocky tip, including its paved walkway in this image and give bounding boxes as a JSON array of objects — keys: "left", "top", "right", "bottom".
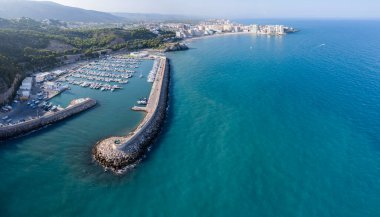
[{"left": 93, "top": 58, "right": 170, "bottom": 171}]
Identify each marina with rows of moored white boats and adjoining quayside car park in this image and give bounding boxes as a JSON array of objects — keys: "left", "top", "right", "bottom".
[{"left": 0, "top": 54, "right": 158, "bottom": 138}]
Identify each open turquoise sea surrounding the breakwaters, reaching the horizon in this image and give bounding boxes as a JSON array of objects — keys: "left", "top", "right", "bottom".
[{"left": 0, "top": 20, "right": 380, "bottom": 217}]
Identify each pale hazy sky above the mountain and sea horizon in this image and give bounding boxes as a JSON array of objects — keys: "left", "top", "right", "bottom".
[{"left": 37, "top": 0, "right": 380, "bottom": 18}]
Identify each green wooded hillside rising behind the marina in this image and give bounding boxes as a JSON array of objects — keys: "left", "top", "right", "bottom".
[{"left": 0, "top": 18, "right": 174, "bottom": 93}]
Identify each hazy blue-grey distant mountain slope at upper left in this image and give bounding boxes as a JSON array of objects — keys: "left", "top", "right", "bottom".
[{"left": 0, "top": 0, "right": 124, "bottom": 23}]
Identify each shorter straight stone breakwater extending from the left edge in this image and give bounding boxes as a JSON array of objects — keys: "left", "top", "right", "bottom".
[{"left": 0, "top": 98, "right": 97, "bottom": 140}]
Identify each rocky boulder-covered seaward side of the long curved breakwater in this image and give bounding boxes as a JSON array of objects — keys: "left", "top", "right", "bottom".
[{"left": 93, "top": 59, "right": 170, "bottom": 171}]
